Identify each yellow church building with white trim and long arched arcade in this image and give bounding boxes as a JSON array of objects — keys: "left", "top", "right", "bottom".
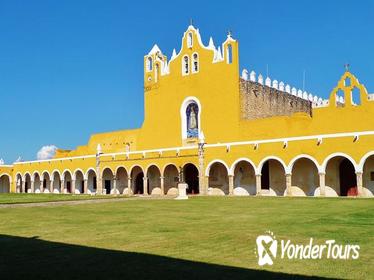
[{"left": 0, "top": 25, "right": 374, "bottom": 197}]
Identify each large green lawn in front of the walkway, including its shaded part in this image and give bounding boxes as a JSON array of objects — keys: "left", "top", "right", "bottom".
[{"left": 0, "top": 197, "right": 374, "bottom": 279}]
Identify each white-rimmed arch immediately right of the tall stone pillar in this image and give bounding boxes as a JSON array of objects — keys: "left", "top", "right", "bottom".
[{"left": 206, "top": 160, "right": 230, "bottom": 195}]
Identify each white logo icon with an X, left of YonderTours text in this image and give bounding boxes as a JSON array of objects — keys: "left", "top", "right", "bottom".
[{"left": 256, "top": 231, "right": 278, "bottom": 266}]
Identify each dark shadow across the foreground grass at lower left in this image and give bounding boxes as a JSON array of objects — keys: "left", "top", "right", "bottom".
[{"left": 0, "top": 235, "right": 334, "bottom": 280}]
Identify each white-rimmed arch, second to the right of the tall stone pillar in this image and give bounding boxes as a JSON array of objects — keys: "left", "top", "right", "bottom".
[{"left": 230, "top": 158, "right": 256, "bottom": 195}]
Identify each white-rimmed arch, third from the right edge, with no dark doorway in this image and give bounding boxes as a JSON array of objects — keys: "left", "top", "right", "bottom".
[{"left": 289, "top": 155, "right": 320, "bottom": 196}]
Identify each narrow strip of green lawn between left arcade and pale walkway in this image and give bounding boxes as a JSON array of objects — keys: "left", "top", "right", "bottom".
[{"left": 0, "top": 193, "right": 118, "bottom": 204}]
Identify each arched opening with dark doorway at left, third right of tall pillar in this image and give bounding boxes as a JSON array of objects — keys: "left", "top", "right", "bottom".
[{"left": 261, "top": 159, "right": 286, "bottom": 196}]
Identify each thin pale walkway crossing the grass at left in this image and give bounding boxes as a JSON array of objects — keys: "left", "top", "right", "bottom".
[{"left": 0, "top": 196, "right": 172, "bottom": 209}]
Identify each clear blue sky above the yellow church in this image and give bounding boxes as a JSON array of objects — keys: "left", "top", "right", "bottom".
[{"left": 0, "top": 0, "right": 374, "bottom": 163}]
